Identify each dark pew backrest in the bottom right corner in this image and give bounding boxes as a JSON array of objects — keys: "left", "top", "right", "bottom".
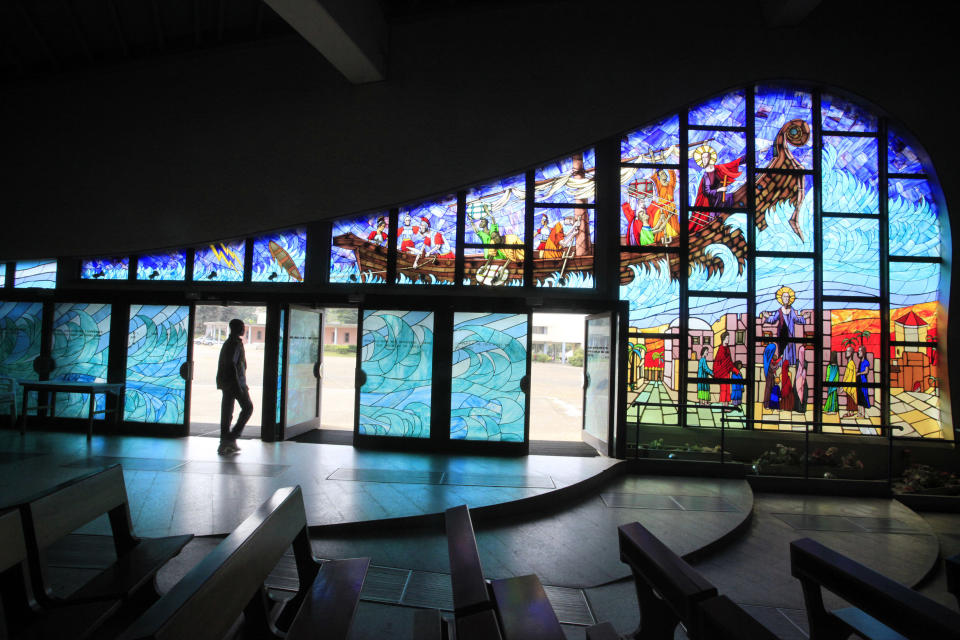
[{"left": 790, "top": 538, "right": 960, "bottom": 638}]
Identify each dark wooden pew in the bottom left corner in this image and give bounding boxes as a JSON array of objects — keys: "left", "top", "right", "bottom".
[{"left": 0, "top": 510, "right": 120, "bottom": 640}]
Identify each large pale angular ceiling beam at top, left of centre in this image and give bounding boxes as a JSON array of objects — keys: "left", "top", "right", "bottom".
[{"left": 264, "top": 0, "right": 387, "bottom": 84}]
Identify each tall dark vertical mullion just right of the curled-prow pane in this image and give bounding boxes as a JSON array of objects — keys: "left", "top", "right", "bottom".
[{"left": 811, "top": 91, "right": 823, "bottom": 433}]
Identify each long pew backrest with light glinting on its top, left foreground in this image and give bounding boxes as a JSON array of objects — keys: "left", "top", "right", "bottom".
[{"left": 120, "top": 487, "right": 316, "bottom": 640}]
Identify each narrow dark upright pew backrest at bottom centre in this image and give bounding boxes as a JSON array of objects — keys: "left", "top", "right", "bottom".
[{"left": 445, "top": 505, "right": 493, "bottom": 616}]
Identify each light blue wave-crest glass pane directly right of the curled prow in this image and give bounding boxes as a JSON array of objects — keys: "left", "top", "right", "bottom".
[{"left": 821, "top": 136, "right": 880, "bottom": 213}]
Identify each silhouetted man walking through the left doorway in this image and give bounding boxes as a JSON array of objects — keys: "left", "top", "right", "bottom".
[{"left": 217, "top": 318, "right": 253, "bottom": 456}]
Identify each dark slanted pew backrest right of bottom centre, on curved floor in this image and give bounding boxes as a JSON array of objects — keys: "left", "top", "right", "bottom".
[{"left": 618, "top": 522, "right": 717, "bottom": 628}]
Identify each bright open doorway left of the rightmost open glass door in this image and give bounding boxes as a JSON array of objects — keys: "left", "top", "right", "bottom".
[{"left": 530, "top": 313, "right": 586, "bottom": 442}]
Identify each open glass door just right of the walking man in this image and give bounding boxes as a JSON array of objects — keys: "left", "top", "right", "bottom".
[{"left": 282, "top": 305, "right": 323, "bottom": 440}]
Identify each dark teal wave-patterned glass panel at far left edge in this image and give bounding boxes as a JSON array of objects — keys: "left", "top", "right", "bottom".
[{"left": 0, "top": 302, "right": 43, "bottom": 392}]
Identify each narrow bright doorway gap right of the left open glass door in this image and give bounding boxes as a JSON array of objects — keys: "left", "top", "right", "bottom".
[{"left": 320, "top": 308, "right": 358, "bottom": 431}]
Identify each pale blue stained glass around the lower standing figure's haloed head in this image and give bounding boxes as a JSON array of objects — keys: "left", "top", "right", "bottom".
[{"left": 756, "top": 256, "right": 814, "bottom": 322}]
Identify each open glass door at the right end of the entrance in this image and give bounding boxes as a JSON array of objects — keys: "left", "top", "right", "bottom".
[{"left": 583, "top": 312, "right": 616, "bottom": 455}]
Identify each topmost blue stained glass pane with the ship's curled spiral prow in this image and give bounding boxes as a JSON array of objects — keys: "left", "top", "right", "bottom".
[{"left": 754, "top": 85, "right": 813, "bottom": 169}]
